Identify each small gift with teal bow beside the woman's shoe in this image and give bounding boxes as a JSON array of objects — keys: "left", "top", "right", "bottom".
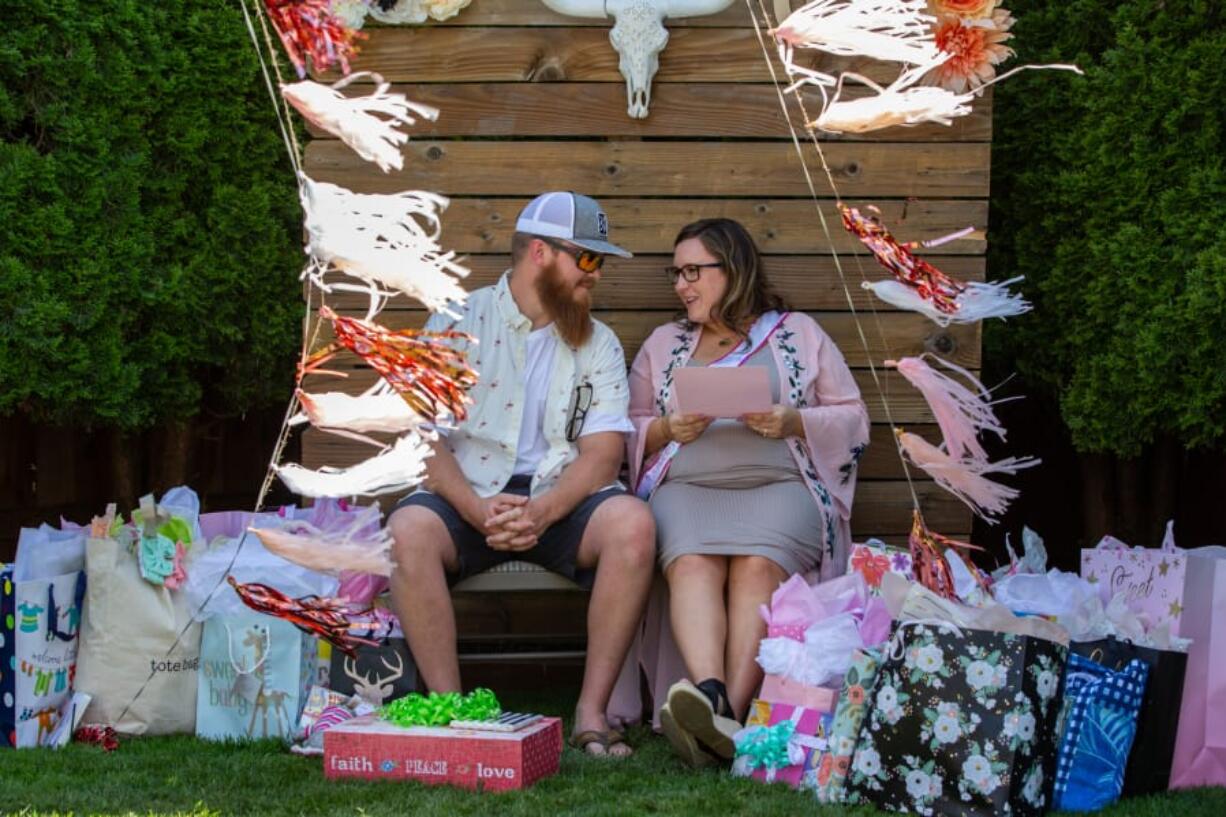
[{"left": 732, "top": 699, "right": 834, "bottom": 789}]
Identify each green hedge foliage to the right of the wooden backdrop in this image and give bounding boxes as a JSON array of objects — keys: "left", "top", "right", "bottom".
[{"left": 988, "top": 0, "right": 1226, "bottom": 456}]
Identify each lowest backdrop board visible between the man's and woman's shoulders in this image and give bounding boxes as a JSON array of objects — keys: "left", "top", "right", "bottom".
[{"left": 320, "top": 309, "right": 980, "bottom": 368}]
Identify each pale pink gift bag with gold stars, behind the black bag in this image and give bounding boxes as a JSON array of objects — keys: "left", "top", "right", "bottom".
[{"left": 1081, "top": 525, "right": 1187, "bottom": 637}]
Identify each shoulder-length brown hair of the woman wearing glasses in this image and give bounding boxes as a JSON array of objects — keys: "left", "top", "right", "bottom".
[{"left": 673, "top": 218, "right": 788, "bottom": 335}]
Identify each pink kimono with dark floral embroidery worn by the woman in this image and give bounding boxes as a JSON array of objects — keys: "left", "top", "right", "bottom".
[{"left": 609, "top": 312, "right": 868, "bottom": 727}]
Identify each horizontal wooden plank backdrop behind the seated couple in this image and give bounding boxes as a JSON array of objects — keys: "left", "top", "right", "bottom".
[{"left": 302, "top": 0, "right": 992, "bottom": 541}]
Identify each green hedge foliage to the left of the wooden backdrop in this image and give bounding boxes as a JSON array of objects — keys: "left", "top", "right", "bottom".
[{"left": 0, "top": 0, "right": 302, "bottom": 429}]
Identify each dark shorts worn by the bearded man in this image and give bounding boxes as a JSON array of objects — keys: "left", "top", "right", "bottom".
[{"left": 392, "top": 476, "right": 626, "bottom": 589}]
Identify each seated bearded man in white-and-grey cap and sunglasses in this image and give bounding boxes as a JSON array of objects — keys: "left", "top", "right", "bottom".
[{"left": 389, "top": 193, "right": 656, "bottom": 757}]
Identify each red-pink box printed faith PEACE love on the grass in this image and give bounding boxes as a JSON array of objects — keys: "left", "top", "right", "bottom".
[{"left": 324, "top": 715, "right": 562, "bottom": 791}]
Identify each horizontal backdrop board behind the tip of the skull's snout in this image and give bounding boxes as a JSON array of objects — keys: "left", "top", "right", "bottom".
[{"left": 311, "top": 82, "right": 992, "bottom": 142}]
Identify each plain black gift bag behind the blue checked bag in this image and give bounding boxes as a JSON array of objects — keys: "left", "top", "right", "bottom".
[{"left": 1069, "top": 638, "right": 1188, "bottom": 797}]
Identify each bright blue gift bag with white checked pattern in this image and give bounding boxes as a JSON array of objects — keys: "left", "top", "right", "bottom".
[{"left": 1052, "top": 654, "right": 1149, "bottom": 811}]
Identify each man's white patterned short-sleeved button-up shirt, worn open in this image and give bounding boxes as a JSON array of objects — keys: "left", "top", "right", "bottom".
[{"left": 425, "top": 272, "right": 633, "bottom": 497}]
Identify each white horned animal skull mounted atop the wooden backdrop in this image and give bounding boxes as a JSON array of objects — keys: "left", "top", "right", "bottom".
[{"left": 542, "top": 0, "right": 733, "bottom": 119}]
